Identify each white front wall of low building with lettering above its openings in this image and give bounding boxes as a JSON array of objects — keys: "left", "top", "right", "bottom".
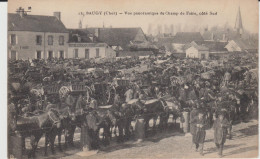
[{"left": 68, "top": 43, "right": 116, "bottom": 58}]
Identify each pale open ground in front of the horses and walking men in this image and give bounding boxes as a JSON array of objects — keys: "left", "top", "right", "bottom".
[{"left": 29, "top": 120, "right": 258, "bottom": 159}]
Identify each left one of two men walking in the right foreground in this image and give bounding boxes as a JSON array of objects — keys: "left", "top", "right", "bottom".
[{"left": 193, "top": 110, "right": 206, "bottom": 156}]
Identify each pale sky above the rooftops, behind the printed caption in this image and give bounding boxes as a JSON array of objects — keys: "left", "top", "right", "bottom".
[{"left": 8, "top": 0, "right": 258, "bottom": 33}]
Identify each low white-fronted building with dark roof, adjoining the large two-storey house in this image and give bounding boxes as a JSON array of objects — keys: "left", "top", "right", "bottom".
[{"left": 68, "top": 29, "right": 116, "bottom": 59}]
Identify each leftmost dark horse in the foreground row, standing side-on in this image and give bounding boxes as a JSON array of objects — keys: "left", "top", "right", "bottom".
[{"left": 11, "top": 109, "right": 61, "bottom": 158}]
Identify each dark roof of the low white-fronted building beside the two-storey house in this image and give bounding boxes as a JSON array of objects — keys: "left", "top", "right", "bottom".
[{"left": 68, "top": 29, "right": 100, "bottom": 43}]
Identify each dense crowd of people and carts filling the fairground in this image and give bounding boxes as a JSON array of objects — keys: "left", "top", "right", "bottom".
[{"left": 8, "top": 54, "right": 258, "bottom": 155}]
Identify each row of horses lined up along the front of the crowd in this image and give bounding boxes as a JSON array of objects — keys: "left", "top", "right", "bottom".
[{"left": 9, "top": 94, "right": 181, "bottom": 157}]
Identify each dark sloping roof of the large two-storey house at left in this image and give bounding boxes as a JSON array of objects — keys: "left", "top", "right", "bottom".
[{"left": 8, "top": 13, "right": 68, "bottom": 33}]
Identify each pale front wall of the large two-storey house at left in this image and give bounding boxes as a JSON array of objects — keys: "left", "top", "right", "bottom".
[{"left": 8, "top": 31, "right": 69, "bottom": 60}]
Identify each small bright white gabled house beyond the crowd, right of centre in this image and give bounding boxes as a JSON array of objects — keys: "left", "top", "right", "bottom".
[{"left": 186, "top": 45, "right": 209, "bottom": 59}]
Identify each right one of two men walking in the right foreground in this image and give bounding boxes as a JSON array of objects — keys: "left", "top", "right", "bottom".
[{"left": 213, "top": 111, "right": 229, "bottom": 157}]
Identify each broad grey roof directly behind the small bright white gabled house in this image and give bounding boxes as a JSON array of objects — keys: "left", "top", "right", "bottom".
[{"left": 173, "top": 32, "right": 204, "bottom": 44}]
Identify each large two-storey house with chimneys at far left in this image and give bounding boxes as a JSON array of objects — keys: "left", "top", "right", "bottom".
[{"left": 8, "top": 8, "right": 69, "bottom": 60}]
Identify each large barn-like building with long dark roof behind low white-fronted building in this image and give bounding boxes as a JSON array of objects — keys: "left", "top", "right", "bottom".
[{"left": 87, "top": 28, "right": 147, "bottom": 51}]
